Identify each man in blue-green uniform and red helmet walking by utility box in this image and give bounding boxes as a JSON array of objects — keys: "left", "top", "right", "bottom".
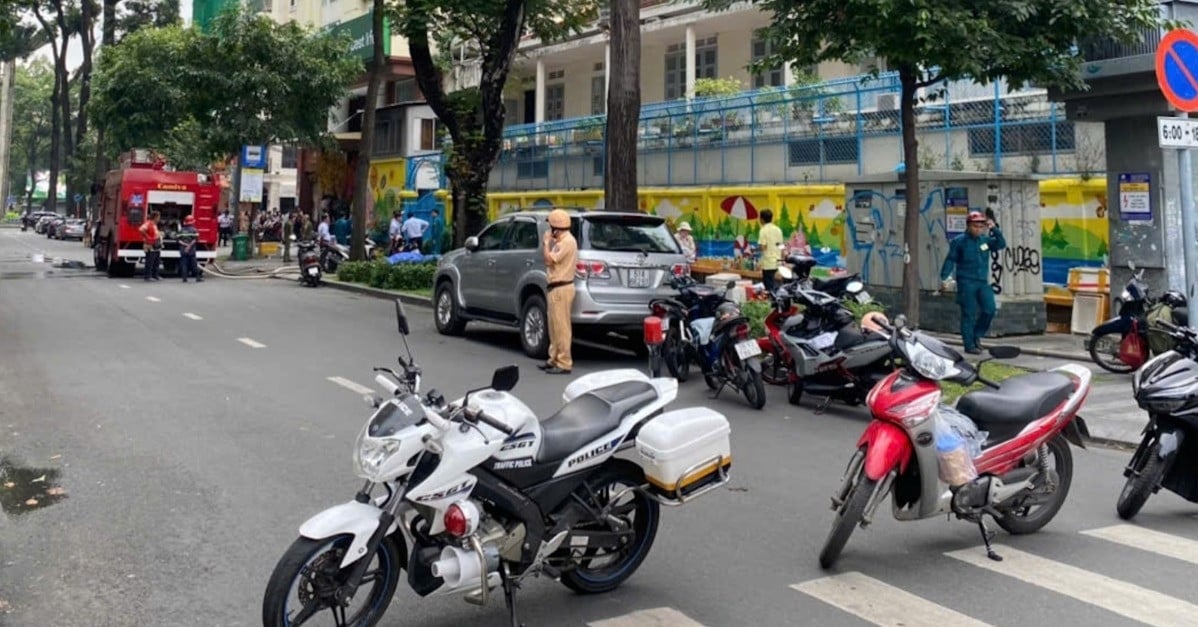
[{"left": 940, "top": 211, "right": 1006, "bottom": 355}]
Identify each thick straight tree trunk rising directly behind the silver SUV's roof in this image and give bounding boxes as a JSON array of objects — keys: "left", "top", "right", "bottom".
[{"left": 604, "top": 0, "right": 641, "bottom": 211}]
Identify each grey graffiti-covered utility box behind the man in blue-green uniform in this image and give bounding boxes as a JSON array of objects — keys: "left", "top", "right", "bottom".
[{"left": 845, "top": 170, "right": 1046, "bottom": 336}]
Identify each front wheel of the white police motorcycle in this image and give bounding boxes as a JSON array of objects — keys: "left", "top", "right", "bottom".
[{"left": 262, "top": 535, "right": 404, "bottom": 627}]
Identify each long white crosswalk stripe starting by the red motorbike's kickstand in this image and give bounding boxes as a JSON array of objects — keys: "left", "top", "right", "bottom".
[{"left": 945, "top": 545, "right": 1198, "bottom": 626}]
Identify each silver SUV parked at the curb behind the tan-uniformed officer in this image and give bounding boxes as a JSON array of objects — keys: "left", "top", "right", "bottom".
[{"left": 432, "top": 209, "right": 689, "bottom": 358}]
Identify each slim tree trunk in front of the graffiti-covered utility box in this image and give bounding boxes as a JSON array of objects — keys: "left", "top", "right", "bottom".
[{"left": 899, "top": 66, "right": 920, "bottom": 326}]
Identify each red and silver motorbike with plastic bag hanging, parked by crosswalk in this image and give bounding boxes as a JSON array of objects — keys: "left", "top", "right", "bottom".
[{"left": 819, "top": 315, "right": 1090, "bottom": 568}]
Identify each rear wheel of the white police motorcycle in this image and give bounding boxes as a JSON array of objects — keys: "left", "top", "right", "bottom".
[{"left": 561, "top": 464, "right": 661, "bottom": 595}]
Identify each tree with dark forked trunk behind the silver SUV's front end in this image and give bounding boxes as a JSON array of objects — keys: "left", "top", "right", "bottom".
[{"left": 391, "top": 0, "right": 599, "bottom": 243}]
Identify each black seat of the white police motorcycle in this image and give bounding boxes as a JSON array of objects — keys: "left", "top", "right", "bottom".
[{"left": 537, "top": 381, "right": 658, "bottom": 464}]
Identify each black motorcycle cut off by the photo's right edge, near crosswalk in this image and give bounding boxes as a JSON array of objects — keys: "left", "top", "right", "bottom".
[{"left": 1115, "top": 321, "right": 1198, "bottom": 520}]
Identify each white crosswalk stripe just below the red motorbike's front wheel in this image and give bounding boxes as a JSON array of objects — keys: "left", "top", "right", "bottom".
[{"left": 791, "top": 572, "right": 988, "bottom": 627}]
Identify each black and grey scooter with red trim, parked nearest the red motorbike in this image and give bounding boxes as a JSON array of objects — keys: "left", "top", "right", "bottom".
[{"left": 758, "top": 282, "right": 894, "bottom": 412}]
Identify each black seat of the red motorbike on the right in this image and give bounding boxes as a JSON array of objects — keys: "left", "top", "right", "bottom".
[{"left": 957, "top": 373, "right": 1073, "bottom": 433}]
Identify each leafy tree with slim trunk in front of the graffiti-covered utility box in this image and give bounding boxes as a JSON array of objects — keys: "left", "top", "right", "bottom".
[{"left": 706, "top": 0, "right": 1160, "bottom": 322}]
